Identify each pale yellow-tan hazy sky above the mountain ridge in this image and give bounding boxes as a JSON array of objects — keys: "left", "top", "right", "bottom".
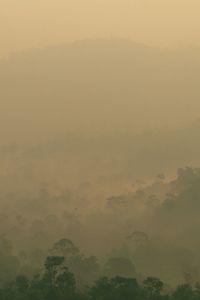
[{"left": 0, "top": 0, "right": 200, "bottom": 55}]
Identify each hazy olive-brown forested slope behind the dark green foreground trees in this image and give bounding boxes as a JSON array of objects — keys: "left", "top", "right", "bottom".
[{"left": 0, "top": 167, "right": 200, "bottom": 289}]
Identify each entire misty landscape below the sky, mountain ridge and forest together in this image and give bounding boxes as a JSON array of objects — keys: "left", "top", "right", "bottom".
[{"left": 0, "top": 38, "right": 200, "bottom": 300}]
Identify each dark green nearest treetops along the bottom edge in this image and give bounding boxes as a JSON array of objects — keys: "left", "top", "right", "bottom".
[{"left": 0, "top": 256, "right": 200, "bottom": 300}]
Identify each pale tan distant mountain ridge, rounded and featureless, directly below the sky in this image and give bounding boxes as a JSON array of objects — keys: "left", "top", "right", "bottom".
[{"left": 0, "top": 39, "right": 200, "bottom": 142}]
